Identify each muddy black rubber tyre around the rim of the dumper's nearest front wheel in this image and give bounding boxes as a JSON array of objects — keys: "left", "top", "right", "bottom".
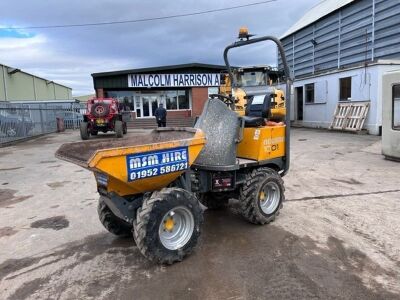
[{"left": 133, "top": 188, "right": 203, "bottom": 265}]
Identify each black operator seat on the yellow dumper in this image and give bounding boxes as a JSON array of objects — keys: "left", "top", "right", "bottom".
[{"left": 242, "top": 93, "right": 272, "bottom": 127}]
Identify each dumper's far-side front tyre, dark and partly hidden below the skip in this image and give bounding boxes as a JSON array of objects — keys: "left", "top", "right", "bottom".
[{"left": 97, "top": 200, "right": 132, "bottom": 237}]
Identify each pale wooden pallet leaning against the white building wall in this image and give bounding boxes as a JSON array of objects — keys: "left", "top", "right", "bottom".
[{"left": 330, "top": 101, "right": 371, "bottom": 131}]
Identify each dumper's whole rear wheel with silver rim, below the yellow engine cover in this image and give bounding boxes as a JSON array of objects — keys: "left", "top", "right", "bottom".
[{"left": 239, "top": 167, "right": 285, "bottom": 225}]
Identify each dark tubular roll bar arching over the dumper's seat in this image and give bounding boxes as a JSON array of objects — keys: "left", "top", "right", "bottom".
[{"left": 224, "top": 36, "right": 292, "bottom": 176}]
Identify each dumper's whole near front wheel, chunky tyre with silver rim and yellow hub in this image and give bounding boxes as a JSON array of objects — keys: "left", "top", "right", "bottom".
[{"left": 133, "top": 188, "right": 203, "bottom": 265}]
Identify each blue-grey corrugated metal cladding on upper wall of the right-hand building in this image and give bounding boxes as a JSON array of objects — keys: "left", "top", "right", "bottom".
[{"left": 279, "top": 0, "right": 400, "bottom": 78}]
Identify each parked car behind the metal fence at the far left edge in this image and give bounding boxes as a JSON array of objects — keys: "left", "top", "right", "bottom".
[{"left": 0, "top": 110, "right": 35, "bottom": 137}]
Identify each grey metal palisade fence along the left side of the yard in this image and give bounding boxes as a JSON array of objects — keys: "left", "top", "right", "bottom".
[{"left": 0, "top": 102, "right": 83, "bottom": 146}]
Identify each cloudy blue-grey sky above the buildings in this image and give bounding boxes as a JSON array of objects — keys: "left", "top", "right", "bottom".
[{"left": 0, "top": 0, "right": 320, "bottom": 96}]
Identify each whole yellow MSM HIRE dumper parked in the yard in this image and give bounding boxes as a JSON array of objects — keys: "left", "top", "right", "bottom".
[{"left": 56, "top": 29, "right": 291, "bottom": 264}]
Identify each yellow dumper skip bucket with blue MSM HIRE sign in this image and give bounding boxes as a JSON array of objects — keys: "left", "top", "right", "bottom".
[{"left": 56, "top": 128, "right": 206, "bottom": 196}]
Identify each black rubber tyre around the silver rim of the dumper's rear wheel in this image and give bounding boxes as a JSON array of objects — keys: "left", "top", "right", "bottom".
[{"left": 239, "top": 167, "right": 285, "bottom": 225}]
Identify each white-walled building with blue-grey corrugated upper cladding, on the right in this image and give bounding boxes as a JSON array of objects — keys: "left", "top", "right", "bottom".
[{"left": 278, "top": 0, "right": 400, "bottom": 134}]
